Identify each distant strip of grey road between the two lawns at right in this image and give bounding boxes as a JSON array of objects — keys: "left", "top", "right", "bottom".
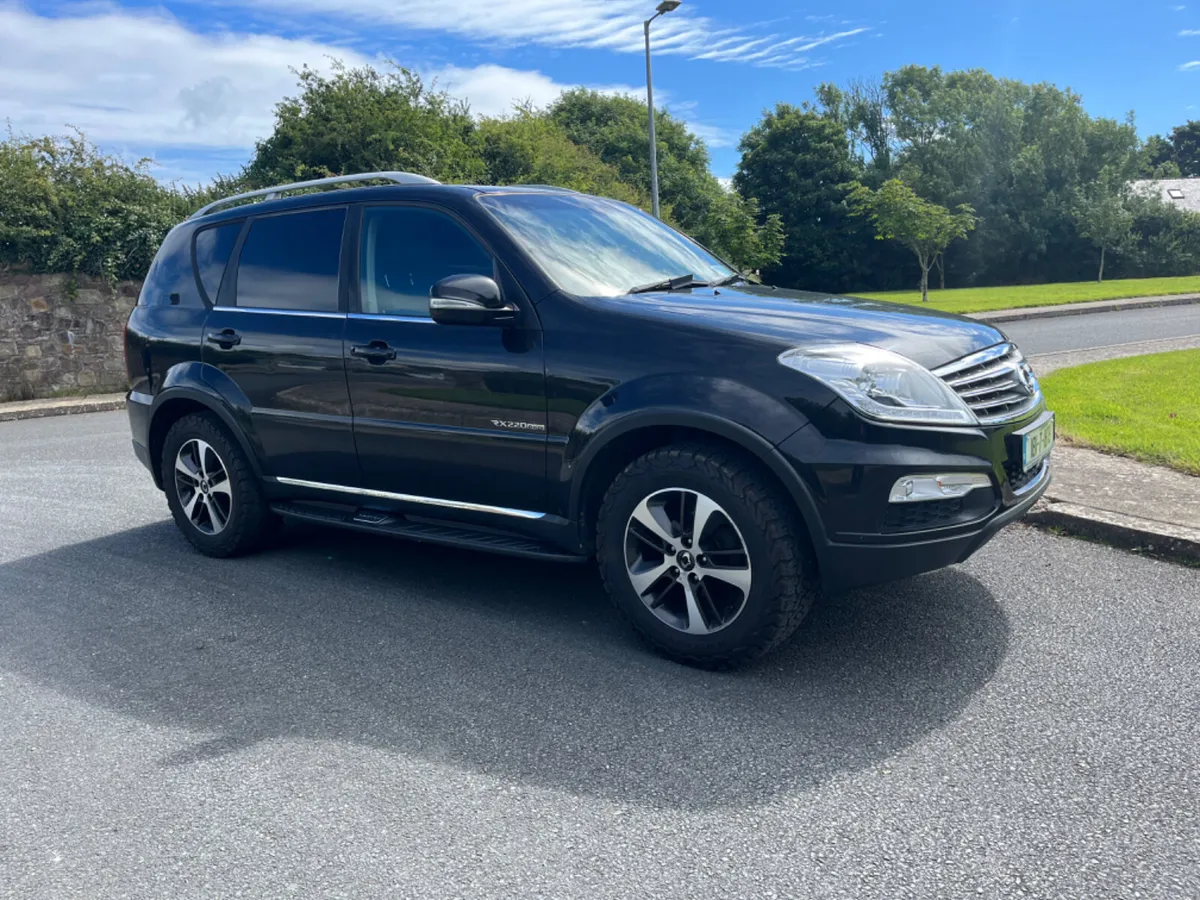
[{"left": 998, "top": 304, "right": 1200, "bottom": 356}]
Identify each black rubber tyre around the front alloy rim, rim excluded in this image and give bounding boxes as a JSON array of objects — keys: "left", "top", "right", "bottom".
[{"left": 596, "top": 444, "right": 817, "bottom": 668}]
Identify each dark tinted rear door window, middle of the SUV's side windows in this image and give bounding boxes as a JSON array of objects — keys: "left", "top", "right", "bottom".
[{"left": 238, "top": 209, "right": 346, "bottom": 312}]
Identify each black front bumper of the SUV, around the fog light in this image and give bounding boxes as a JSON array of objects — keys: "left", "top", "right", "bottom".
[{"left": 778, "top": 403, "right": 1050, "bottom": 590}]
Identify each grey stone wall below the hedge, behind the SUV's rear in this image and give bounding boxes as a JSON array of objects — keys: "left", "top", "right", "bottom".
[{"left": 0, "top": 272, "right": 140, "bottom": 402}]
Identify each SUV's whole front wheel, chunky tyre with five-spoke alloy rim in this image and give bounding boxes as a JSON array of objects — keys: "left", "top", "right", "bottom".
[{"left": 596, "top": 444, "right": 815, "bottom": 668}]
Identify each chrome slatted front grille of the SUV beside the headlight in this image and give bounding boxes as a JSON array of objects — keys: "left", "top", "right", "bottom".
[{"left": 934, "top": 343, "right": 1042, "bottom": 425}]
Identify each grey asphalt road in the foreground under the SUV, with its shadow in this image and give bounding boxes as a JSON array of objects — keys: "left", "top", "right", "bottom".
[{"left": 0, "top": 412, "right": 1200, "bottom": 900}]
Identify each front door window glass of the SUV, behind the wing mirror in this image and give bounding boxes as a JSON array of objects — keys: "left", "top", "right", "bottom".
[{"left": 360, "top": 206, "right": 494, "bottom": 318}]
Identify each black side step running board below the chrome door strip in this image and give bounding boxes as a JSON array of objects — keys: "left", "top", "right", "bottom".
[{"left": 271, "top": 503, "right": 587, "bottom": 563}]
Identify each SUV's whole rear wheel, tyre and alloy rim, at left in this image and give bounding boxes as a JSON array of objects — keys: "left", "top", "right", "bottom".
[{"left": 162, "top": 413, "right": 277, "bottom": 557}]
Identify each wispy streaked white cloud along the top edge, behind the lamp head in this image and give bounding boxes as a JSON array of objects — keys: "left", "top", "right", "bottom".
[{"left": 222, "top": 0, "right": 869, "bottom": 68}]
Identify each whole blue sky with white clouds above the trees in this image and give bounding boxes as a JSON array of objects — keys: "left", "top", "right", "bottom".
[{"left": 0, "top": 0, "right": 1200, "bottom": 182}]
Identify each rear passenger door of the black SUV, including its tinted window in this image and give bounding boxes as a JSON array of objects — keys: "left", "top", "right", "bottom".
[{"left": 203, "top": 206, "right": 359, "bottom": 485}]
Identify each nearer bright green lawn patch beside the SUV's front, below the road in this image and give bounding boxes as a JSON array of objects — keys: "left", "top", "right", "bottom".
[{"left": 1042, "top": 350, "right": 1200, "bottom": 475}]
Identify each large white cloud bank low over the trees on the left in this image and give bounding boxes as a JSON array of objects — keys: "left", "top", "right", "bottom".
[{"left": 0, "top": 5, "right": 676, "bottom": 172}]
